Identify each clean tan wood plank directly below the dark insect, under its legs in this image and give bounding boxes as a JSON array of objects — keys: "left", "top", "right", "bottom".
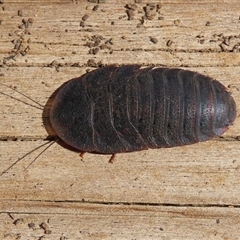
[{"left": 0, "top": 141, "right": 240, "bottom": 206}]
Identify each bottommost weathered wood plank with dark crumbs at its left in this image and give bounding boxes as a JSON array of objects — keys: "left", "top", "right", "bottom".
[{"left": 0, "top": 201, "right": 240, "bottom": 240}]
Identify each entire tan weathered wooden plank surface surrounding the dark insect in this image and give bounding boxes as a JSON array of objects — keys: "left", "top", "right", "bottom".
[{"left": 0, "top": 0, "right": 240, "bottom": 240}]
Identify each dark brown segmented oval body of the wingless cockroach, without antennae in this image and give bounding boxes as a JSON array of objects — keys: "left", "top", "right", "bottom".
[{"left": 50, "top": 65, "right": 236, "bottom": 154}]
